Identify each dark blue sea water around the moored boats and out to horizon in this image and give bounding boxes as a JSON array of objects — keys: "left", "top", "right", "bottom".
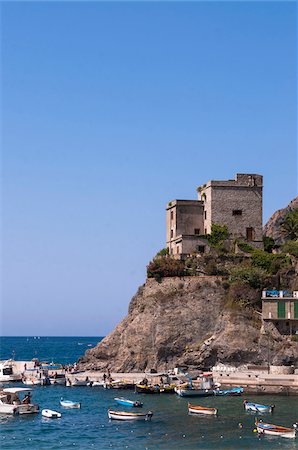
[{"left": 0, "top": 336, "right": 298, "bottom": 450}]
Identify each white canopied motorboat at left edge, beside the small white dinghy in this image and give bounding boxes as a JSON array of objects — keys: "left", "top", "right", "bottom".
[{"left": 0, "top": 388, "right": 39, "bottom": 415}]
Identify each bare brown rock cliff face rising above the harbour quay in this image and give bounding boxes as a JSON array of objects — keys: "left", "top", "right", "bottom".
[{"left": 79, "top": 277, "right": 298, "bottom": 372}]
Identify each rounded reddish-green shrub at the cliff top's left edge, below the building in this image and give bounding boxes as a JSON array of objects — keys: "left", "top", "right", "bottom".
[{"left": 147, "top": 256, "right": 185, "bottom": 280}]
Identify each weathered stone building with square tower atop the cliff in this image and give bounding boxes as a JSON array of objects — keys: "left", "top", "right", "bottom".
[{"left": 167, "top": 174, "right": 263, "bottom": 256}]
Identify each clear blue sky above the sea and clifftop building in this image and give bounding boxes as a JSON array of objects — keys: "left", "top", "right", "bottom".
[{"left": 1, "top": 2, "right": 297, "bottom": 335}]
